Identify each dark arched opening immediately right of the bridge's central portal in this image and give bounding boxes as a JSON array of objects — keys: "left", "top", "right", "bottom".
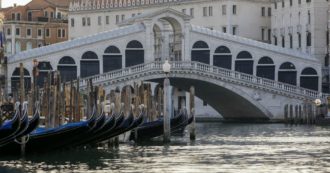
[{"left": 191, "top": 41, "right": 210, "bottom": 64}]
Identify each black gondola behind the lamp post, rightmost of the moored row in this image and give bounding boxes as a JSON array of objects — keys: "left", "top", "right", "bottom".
[{"left": 130, "top": 112, "right": 184, "bottom": 141}]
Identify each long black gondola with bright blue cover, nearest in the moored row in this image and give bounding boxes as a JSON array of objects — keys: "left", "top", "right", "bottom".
[{"left": 0, "top": 108, "right": 96, "bottom": 155}]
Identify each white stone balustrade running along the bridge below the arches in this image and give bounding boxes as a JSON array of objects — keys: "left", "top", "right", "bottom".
[{"left": 80, "top": 62, "right": 327, "bottom": 99}]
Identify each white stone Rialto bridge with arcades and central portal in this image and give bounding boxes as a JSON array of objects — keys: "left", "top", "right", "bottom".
[{"left": 8, "top": 9, "right": 323, "bottom": 119}]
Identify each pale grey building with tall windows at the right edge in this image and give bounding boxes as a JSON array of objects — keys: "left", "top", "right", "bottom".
[{"left": 272, "top": 0, "right": 330, "bottom": 92}]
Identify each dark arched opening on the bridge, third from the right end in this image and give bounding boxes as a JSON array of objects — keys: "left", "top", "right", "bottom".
[{"left": 257, "top": 56, "right": 275, "bottom": 80}]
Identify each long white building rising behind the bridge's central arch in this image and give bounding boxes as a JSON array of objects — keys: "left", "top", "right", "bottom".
[{"left": 69, "top": 0, "right": 272, "bottom": 42}]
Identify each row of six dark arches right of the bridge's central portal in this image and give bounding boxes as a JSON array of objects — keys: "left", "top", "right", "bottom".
[{"left": 191, "top": 41, "right": 319, "bottom": 91}]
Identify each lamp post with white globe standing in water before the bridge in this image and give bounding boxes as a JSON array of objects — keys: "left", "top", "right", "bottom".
[{"left": 163, "top": 60, "right": 172, "bottom": 143}]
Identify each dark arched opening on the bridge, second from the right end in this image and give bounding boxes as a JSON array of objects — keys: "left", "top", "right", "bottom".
[{"left": 278, "top": 62, "right": 297, "bottom": 85}]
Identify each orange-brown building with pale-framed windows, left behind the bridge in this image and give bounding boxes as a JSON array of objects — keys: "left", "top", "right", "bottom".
[{"left": 3, "top": 0, "right": 68, "bottom": 55}]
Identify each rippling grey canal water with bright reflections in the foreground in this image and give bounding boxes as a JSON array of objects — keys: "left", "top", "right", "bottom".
[{"left": 0, "top": 123, "right": 330, "bottom": 173}]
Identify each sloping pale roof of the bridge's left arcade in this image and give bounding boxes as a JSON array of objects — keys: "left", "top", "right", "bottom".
[{"left": 8, "top": 24, "right": 145, "bottom": 63}]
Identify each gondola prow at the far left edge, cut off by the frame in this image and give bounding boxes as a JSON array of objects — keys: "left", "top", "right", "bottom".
[{"left": 0, "top": 103, "right": 21, "bottom": 142}]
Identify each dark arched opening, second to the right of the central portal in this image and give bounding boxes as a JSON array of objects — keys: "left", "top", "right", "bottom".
[{"left": 213, "top": 46, "right": 232, "bottom": 69}]
